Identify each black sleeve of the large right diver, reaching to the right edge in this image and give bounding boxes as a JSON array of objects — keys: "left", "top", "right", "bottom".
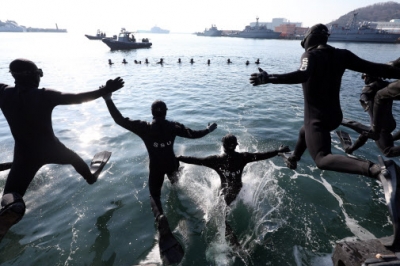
[{"left": 343, "top": 50, "right": 400, "bottom": 79}]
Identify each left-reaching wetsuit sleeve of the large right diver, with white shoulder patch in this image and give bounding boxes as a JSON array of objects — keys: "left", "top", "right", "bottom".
[{"left": 268, "top": 52, "right": 315, "bottom": 84}]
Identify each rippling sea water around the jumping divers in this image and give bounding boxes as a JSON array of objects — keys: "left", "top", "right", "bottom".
[{"left": 0, "top": 33, "right": 400, "bottom": 266}]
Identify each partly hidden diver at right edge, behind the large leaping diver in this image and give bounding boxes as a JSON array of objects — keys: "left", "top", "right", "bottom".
[{"left": 342, "top": 73, "right": 400, "bottom": 157}]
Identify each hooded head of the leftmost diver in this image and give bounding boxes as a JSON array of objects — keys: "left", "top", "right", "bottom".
[{"left": 10, "top": 58, "right": 43, "bottom": 87}]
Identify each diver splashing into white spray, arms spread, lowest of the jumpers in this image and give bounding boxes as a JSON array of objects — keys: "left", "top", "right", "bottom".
[{"left": 177, "top": 134, "right": 289, "bottom": 245}]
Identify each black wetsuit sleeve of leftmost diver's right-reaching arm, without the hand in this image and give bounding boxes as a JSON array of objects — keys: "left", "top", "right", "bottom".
[{"left": 46, "top": 89, "right": 105, "bottom": 105}]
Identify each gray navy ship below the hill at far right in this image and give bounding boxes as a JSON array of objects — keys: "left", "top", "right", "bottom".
[{"left": 328, "top": 13, "right": 400, "bottom": 43}]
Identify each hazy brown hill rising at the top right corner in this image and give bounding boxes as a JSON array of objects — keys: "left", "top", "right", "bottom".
[{"left": 327, "top": 1, "right": 400, "bottom": 25}]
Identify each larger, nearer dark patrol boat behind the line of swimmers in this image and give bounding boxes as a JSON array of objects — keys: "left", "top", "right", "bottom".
[{"left": 101, "top": 28, "right": 152, "bottom": 50}]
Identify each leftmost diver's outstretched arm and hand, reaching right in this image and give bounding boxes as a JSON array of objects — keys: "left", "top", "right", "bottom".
[{"left": 56, "top": 77, "right": 124, "bottom": 105}]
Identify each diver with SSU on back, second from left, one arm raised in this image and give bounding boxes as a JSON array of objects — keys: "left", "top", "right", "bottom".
[{"left": 103, "top": 94, "right": 217, "bottom": 253}]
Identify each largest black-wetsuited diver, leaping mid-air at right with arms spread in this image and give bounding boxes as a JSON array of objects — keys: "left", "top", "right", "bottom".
[{"left": 250, "top": 24, "right": 400, "bottom": 178}]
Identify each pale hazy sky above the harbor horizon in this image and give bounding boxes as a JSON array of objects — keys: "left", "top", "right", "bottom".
[{"left": 0, "top": 0, "right": 399, "bottom": 34}]
